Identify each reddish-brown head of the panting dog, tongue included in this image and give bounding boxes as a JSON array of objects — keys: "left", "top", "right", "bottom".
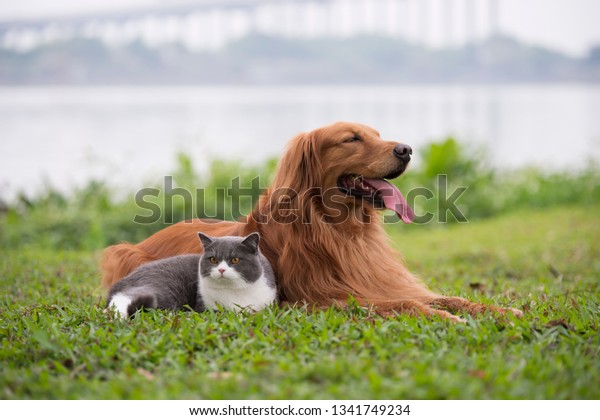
[{"left": 276, "top": 122, "right": 414, "bottom": 223}]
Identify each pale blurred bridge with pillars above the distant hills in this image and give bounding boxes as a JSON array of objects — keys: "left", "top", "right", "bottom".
[{"left": 0, "top": 0, "right": 500, "bottom": 50}]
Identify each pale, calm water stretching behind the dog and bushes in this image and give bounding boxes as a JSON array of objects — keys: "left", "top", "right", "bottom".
[{"left": 0, "top": 85, "right": 600, "bottom": 197}]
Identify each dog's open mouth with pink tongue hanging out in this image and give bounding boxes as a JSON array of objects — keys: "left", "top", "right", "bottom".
[{"left": 338, "top": 175, "right": 415, "bottom": 223}]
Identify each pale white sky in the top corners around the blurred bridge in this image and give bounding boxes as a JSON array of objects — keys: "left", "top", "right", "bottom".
[{"left": 0, "top": 0, "right": 600, "bottom": 56}]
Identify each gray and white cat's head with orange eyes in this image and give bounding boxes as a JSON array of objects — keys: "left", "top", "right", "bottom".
[{"left": 198, "top": 232, "right": 262, "bottom": 287}]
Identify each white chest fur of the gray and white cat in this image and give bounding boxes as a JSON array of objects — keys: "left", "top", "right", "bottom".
[{"left": 199, "top": 275, "right": 276, "bottom": 311}]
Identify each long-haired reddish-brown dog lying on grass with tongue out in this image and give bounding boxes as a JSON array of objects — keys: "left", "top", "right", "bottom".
[{"left": 102, "top": 123, "right": 521, "bottom": 322}]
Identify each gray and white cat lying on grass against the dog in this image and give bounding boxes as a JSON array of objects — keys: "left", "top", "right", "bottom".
[{"left": 107, "top": 232, "right": 277, "bottom": 317}]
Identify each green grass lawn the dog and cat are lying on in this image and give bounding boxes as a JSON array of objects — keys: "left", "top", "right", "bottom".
[{"left": 0, "top": 205, "right": 600, "bottom": 399}]
